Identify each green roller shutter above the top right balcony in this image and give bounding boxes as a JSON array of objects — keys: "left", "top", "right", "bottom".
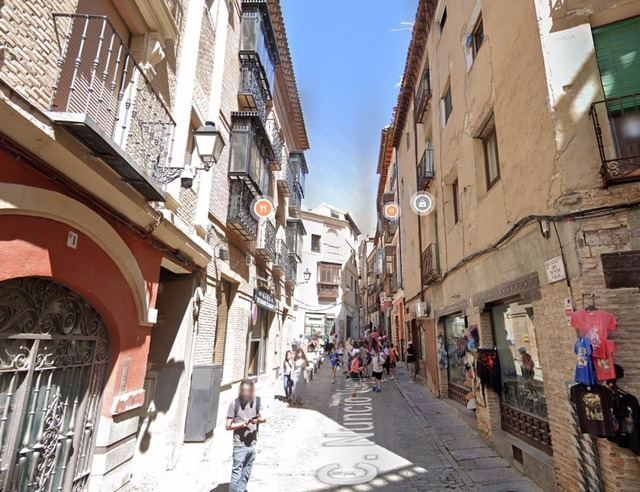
[{"left": 593, "top": 17, "right": 640, "bottom": 111}]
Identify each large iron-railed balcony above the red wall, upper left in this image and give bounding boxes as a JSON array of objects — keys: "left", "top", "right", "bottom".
[{"left": 48, "top": 14, "right": 181, "bottom": 201}]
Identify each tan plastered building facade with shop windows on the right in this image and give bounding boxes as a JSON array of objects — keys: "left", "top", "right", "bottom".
[{"left": 378, "top": 0, "right": 640, "bottom": 491}]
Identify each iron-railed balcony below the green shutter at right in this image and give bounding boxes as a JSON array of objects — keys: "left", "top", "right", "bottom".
[{"left": 591, "top": 93, "right": 640, "bottom": 186}]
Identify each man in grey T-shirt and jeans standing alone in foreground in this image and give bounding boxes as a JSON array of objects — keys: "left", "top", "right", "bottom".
[{"left": 226, "top": 379, "right": 266, "bottom": 492}]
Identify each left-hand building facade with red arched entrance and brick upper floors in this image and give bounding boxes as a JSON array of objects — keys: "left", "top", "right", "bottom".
[{"left": 0, "top": 0, "right": 308, "bottom": 490}]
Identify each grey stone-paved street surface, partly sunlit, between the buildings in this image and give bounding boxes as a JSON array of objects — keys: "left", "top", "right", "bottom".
[{"left": 134, "top": 364, "right": 539, "bottom": 492}]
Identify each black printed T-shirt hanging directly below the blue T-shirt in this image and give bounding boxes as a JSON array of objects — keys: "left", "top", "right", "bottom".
[{"left": 571, "top": 384, "right": 615, "bottom": 437}]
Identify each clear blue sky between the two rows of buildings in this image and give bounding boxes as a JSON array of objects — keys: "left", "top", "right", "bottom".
[{"left": 281, "top": 0, "right": 418, "bottom": 238}]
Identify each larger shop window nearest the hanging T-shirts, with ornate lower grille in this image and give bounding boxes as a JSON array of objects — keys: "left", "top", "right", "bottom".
[{"left": 491, "top": 303, "right": 547, "bottom": 420}]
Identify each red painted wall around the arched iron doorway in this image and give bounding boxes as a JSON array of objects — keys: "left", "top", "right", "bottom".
[{"left": 0, "top": 149, "right": 162, "bottom": 416}]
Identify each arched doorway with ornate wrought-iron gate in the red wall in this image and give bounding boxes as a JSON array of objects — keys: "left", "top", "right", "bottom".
[{"left": 0, "top": 277, "right": 109, "bottom": 491}]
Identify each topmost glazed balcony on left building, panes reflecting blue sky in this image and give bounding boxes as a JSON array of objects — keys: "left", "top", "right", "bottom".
[{"left": 240, "top": 0, "right": 280, "bottom": 100}]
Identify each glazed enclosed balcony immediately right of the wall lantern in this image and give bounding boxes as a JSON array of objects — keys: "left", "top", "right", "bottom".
[{"left": 229, "top": 111, "right": 275, "bottom": 195}]
